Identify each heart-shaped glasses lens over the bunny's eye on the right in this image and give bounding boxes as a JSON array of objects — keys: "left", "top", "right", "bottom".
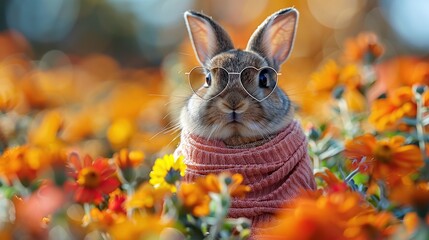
[{"left": 240, "top": 67, "right": 278, "bottom": 101}]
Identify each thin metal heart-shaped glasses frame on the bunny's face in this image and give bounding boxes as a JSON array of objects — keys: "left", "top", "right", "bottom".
[{"left": 185, "top": 66, "right": 282, "bottom": 102}]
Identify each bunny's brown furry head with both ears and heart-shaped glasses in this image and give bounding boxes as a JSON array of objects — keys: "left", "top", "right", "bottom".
[{"left": 180, "top": 8, "right": 298, "bottom": 140}]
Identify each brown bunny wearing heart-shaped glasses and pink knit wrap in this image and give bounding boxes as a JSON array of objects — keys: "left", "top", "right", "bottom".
[{"left": 176, "top": 8, "right": 316, "bottom": 232}]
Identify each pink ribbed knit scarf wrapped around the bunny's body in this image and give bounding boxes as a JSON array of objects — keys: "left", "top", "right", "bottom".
[{"left": 176, "top": 121, "right": 316, "bottom": 226}]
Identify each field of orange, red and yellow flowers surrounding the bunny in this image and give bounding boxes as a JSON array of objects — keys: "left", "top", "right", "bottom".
[{"left": 0, "top": 1, "right": 429, "bottom": 240}]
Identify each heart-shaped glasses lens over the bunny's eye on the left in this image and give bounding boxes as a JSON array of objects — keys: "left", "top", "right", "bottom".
[{"left": 189, "top": 67, "right": 228, "bottom": 100}]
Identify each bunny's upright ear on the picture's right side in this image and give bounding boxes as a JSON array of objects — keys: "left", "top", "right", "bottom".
[{"left": 247, "top": 8, "right": 299, "bottom": 69}]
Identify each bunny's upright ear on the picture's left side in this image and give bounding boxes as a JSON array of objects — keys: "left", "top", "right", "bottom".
[{"left": 185, "top": 11, "right": 234, "bottom": 66}]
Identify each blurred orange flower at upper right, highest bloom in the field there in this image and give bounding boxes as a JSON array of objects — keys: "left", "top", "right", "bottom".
[{"left": 344, "top": 32, "right": 384, "bottom": 64}]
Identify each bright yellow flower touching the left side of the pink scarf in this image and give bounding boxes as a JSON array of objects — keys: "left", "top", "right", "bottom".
[{"left": 149, "top": 154, "right": 186, "bottom": 192}]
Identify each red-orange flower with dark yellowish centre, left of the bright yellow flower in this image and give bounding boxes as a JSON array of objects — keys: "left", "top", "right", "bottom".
[{"left": 69, "top": 153, "right": 120, "bottom": 204}]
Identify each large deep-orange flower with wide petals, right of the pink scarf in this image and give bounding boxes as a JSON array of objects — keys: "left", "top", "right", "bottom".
[{"left": 345, "top": 134, "right": 423, "bottom": 181}]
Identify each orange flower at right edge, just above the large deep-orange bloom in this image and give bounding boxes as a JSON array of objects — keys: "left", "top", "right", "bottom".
[{"left": 369, "top": 87, "right": 429, "bottom": 131}]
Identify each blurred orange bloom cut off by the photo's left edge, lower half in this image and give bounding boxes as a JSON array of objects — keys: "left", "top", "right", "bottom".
[{"left": 0, "top": 145, "right": 48, "bottom": 185}]
